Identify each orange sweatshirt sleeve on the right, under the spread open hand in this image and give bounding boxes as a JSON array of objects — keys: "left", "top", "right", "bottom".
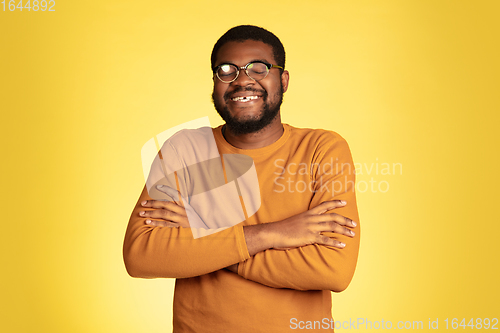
[{"left": 238, "top": 136, "right": 360, "bottom": 292}]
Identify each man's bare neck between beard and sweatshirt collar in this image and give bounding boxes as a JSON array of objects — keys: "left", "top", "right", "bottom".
[{"left": 223, "top": 114, "right": 284, "bottom": 149}]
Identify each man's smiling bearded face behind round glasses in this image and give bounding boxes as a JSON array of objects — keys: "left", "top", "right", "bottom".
[{"left": 212, "top": 40, "right": 288, "bottom": 135}]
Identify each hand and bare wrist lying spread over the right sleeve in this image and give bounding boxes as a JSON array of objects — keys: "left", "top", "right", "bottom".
[{"left": 244, "top": 200, "right": 356, "bottom": 255}]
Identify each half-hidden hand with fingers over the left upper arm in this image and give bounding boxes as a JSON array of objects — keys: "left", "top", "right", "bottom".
[{"left": 139, "top": 200, "right": 189, "bottom": 228}]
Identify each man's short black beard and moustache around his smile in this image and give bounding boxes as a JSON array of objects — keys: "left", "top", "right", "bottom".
[{"left": 212, "top": 82, "right": 283, "bottom": 135}]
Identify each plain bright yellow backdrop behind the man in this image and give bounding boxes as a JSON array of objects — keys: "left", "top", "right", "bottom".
[{"left": 0, "top": 0, "right": 500, "bottom": 333}]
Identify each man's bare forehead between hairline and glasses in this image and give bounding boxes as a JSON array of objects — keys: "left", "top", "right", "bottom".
[{"left": 215, "top": 40, "right": 276, "bottom": 66}]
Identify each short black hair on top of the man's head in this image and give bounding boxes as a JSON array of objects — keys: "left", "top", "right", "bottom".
[{"left": 211, "top": 25, "right": 285, "bottom": 71}]
